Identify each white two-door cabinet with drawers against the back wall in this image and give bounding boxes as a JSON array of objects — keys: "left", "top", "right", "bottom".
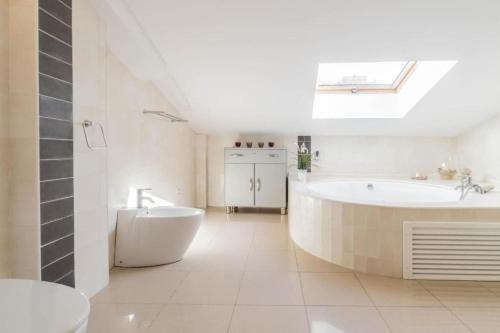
[{"left": 224, "top": 148, "right": 287, "bottom": 213}]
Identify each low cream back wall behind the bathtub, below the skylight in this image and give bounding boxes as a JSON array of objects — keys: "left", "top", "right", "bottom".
[{"left": 312, "top": 136, "right": 455, "bottom": 177}]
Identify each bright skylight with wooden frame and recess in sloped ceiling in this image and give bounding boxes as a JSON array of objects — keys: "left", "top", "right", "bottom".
[{"left": 313, "top": 61, "right": 457, "bottom": 119}]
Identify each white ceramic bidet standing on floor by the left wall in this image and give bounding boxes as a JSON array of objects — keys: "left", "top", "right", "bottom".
[{"left": 115, "top": 207, "right": 205, "bottom": 267}]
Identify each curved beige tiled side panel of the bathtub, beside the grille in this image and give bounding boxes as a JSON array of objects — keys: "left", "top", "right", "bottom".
[{"left": 288, "top": 181, "right": 500, "bottom": 278}]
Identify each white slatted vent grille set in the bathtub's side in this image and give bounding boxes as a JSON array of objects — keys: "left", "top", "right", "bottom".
[{"left": 403, "top": 222, "right": 500, "bottom": 281}]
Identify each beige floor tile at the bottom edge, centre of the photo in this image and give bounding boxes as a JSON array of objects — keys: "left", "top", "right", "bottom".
[{"left": 229, "top": 305, "right": 308, "bottom": 333}]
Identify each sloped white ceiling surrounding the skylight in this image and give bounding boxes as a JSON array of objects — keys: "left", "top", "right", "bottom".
[{"left": 108, "top": 0, "right": 500, "bottom": 136}]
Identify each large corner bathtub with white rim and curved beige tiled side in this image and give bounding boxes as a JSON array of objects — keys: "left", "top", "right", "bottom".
[{"left": 288, "top": 179, "right": 500, "bottom": 278}]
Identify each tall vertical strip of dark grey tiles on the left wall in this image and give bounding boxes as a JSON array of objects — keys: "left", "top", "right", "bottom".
[{"left": 38, "top": 0, "right": 75, "bottom": 287}]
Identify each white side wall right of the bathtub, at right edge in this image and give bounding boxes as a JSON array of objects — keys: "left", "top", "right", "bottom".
[{"left": 457, "top": 115, "right": 500, "bottom": 183}]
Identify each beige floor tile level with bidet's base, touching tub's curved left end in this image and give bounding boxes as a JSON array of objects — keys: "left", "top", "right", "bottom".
[{"left": 246, "top": 250, "right": 297, "bottom": 272}]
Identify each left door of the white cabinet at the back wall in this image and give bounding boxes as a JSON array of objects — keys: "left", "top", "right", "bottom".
[{"left": 224, "top": 163, "right": 255, "bottom": 207}]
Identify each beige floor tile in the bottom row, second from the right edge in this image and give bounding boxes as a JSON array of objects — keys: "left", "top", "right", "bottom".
[{"left": 379, "top": 307, "right": 470, "bottom": 333}]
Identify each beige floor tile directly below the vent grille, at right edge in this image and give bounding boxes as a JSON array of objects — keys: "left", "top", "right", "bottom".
[{"left": 419, "top": 281, "right": 500, "bottom": 307}]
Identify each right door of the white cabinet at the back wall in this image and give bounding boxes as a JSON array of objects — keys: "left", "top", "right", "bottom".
[{"left": 255, "top": 164, "right": 286, "bottom": 208}]
